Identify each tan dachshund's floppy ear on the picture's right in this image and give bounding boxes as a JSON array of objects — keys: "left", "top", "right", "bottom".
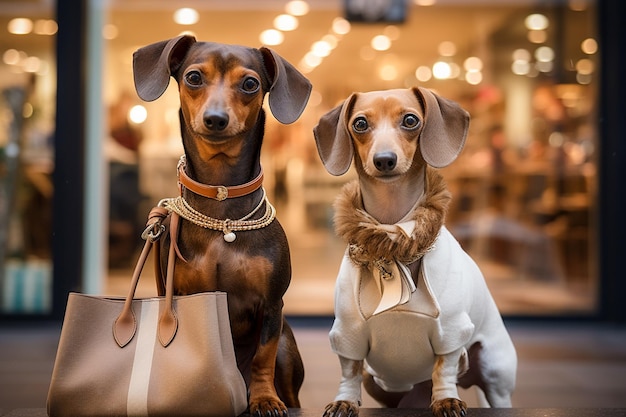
[{"left": 413, "top": 87, "right": 469, "bottom": 168}]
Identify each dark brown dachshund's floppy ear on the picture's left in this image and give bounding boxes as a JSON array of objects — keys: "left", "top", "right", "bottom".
[{"left": 133, "top": 35, "right": 196, "bottom": 101}]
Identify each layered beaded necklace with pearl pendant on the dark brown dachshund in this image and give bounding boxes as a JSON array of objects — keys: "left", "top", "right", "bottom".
[{"left": 159, "top": 189, "right": 276, "bottom": 243}]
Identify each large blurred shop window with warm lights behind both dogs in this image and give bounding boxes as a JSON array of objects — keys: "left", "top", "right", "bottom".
[{"left": 98, "top": 0, "right": 599, "bottom": 316}]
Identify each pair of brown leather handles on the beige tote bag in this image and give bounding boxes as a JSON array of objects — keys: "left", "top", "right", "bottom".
[{"left": 113, "top": 207, "right": 180, "bottom": 347}]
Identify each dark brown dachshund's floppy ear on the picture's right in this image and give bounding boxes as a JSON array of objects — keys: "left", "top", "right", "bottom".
[{"left": 259, "top": 47, "right": 312, "bottom": 124}]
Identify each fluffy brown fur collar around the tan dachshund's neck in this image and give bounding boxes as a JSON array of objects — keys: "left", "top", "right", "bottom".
[{"left": 334, "top": 167, "right": 451, "bottom": 266}]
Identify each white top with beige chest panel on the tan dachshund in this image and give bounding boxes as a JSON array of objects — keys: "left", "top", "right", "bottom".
[{"left": 330, "top": 227, "right": 512, "bottom": 391}]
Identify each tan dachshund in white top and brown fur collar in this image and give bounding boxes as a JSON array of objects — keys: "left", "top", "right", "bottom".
[{"left": 314, "top": 88, "right": 517, "bottom": 417}]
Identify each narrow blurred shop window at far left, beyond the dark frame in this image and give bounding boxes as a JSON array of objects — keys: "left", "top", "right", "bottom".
[{"left": 0, "top": 1, "right": 57, "bottom": 315}]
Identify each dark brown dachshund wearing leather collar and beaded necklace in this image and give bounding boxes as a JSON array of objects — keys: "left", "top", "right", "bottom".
[{"left": 133, "top": 36, "right": 311, "bottom": 416}]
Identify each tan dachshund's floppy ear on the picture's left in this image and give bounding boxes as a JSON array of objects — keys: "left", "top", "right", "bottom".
[{"left": 313, "top": 93, "right": 357, "bottom": 175}]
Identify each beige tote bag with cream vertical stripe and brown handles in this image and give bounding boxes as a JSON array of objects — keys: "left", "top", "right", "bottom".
[{"left": 48, "top": 215, "right": 247, "bottom": 417}]
